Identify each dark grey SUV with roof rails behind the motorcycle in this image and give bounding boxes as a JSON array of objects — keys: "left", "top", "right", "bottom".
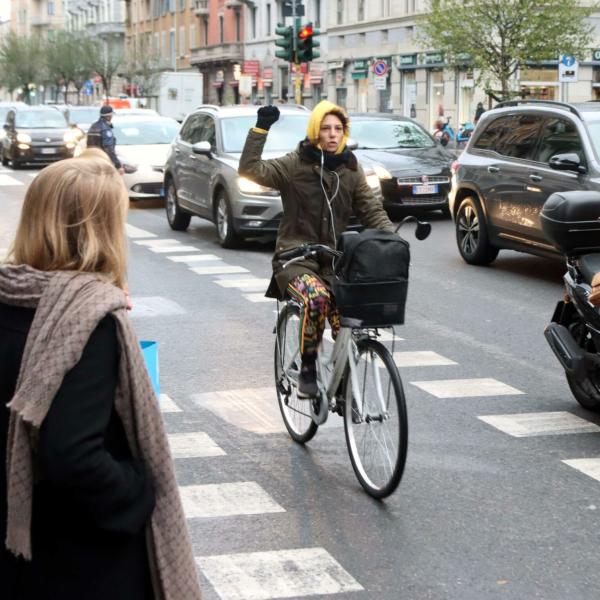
[{"left": 449, "top": 100, "right": 600, "bottom": 265}]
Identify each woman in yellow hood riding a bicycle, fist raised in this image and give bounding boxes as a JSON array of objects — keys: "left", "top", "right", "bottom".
[{"left": 238, "top": 100, "right": 394, "bottom": 398}]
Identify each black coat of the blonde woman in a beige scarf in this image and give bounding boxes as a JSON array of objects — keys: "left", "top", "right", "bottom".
[{"left": 0, "top": 303, "right": 157, "bottom": 600}]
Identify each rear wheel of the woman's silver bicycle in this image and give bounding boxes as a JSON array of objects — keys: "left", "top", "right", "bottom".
[{"left": 275, "top": 303, "right": 319, "bottom": 444}]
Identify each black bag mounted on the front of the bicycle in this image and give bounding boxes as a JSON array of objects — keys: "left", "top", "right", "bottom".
[{"left": 333, "top": 229, "right": 410, "bottom": 327}]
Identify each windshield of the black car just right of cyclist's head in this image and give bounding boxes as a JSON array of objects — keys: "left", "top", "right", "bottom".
[{"left": 350, "top": 118, "right": 435, "bottom": 150}]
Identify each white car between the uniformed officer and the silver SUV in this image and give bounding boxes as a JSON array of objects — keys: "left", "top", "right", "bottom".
[{"left": 112, "top": 111, "right": 180, "bottom": 200}]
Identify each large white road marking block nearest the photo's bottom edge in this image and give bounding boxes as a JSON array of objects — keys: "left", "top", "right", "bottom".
[{"left": 196, "top": 548, "right": 364, "bottom": 600}]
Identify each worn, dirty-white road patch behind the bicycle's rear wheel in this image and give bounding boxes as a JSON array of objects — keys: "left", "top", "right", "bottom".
[{"left": 192, "top": 387, "right": 344, "bottom": 435}]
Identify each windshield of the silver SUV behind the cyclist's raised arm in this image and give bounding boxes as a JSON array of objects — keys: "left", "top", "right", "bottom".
[{"left": 221, "top": 112, "right": 310, "bottom": 153}]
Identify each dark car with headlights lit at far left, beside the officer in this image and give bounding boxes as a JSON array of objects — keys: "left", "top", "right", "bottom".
[{"left": 2, "top": 106, "right": 78, "bottom": 169}]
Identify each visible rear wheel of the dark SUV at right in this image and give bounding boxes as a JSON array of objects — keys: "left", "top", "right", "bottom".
[{"left": 456, "top": 197, "right": 499, "bottom": 265}]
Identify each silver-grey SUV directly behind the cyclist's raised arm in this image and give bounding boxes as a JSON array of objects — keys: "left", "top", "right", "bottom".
[{"left": 164, "top": 105, "right": 381, "bottom": 248}]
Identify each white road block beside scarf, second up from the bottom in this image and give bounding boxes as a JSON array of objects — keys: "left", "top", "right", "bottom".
[{"left": 179, "top": 481, "right": 285, "bottom": 519}]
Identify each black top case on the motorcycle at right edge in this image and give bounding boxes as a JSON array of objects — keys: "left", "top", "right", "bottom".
[{"left": 540, "top": 191, "right": 600, "bottom": 255}]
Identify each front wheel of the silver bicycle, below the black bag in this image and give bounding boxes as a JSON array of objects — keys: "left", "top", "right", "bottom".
[{"left": 344, "top": 339, "right": 408, "bottom": 498}]
